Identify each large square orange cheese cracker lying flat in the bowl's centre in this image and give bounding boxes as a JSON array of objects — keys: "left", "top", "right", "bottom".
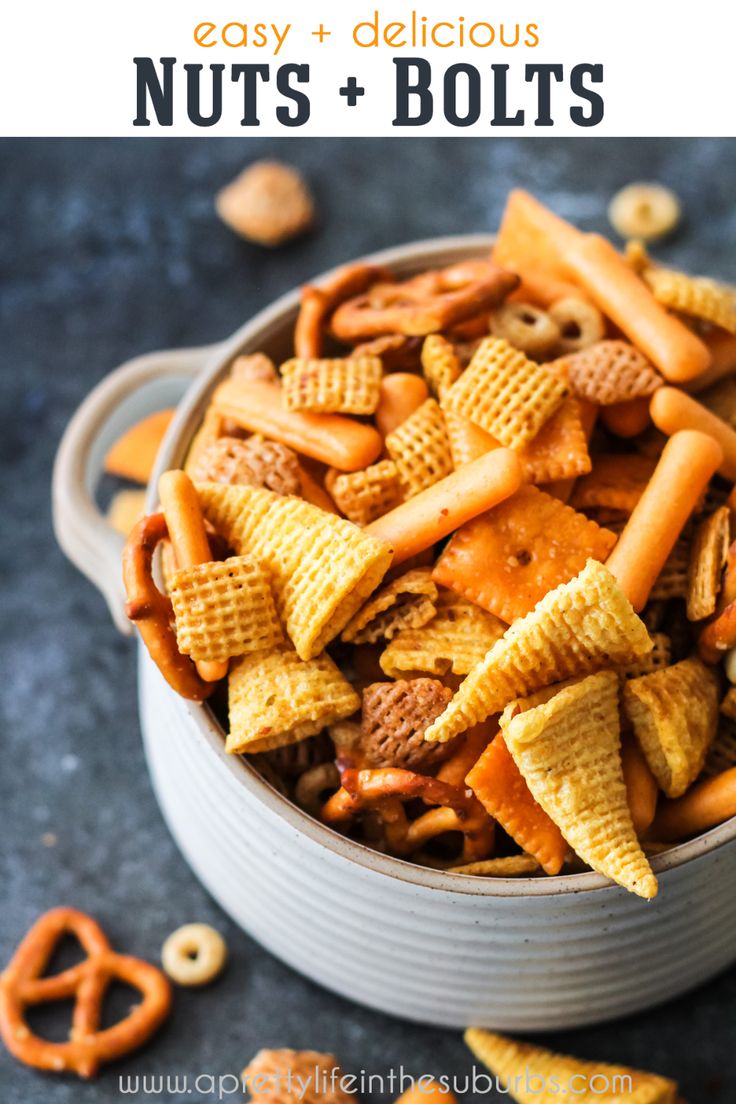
[{"left": 433, "top": 486, "right": 616, "bottom": 624}]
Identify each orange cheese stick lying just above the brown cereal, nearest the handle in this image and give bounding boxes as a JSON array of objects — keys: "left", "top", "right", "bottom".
[{"left": 213, "top": 380, "right": 383, "bottom": 471}]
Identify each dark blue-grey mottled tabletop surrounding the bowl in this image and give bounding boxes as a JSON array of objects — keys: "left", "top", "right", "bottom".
[{"left": 0, "top": 138, "right": 736, "bottom": 1104}]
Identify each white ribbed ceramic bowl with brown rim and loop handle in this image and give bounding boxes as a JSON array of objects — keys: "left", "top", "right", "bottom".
[{"left": 54, "top": 237, "right": 736, "bottom": 1030}]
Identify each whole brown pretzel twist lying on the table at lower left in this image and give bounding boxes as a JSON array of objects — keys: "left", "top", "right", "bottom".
[{"left": 0, "top": 909, "right": 171, "bottom": 1078}]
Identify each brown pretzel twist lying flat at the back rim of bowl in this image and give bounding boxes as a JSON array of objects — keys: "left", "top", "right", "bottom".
[{"left": 330, "top": 261, "right": 519, "bottom": 342}]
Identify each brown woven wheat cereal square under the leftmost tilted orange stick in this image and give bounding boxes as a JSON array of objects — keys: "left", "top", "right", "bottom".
[{"left": 190, "top": 436, "right": 301, "bottom": 495}]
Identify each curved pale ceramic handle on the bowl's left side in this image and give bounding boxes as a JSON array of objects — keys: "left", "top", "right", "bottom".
[{"left": 52, "top": 344, "right": 221, "bottom": 634}]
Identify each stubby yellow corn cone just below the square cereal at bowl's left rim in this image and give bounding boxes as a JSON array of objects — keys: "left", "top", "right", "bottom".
[{"left": 225, "top": 647, "right": 361, "bottom": 754}]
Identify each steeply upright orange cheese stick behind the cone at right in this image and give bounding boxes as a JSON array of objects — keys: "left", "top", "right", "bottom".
[{"left": 606, "top": 429, "right": 723, "bottom": 611}]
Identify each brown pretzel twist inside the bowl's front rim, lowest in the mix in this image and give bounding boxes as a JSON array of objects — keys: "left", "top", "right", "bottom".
[{"left": 321, "top": 760, "right": 493, "bottom": 862}]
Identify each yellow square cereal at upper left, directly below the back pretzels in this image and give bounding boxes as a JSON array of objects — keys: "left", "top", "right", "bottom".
[{"left": 281, "top": 357, "right": 383, "bottom": 414}]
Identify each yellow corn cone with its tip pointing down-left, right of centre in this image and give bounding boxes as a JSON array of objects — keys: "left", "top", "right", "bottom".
[{"left": 425, "top": 560, "right": 652, "bottom": 741}]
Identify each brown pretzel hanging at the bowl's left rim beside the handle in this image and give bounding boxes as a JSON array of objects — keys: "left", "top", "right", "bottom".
[{"left": 122, "top": 513, "right": 215, "bottom": 701}]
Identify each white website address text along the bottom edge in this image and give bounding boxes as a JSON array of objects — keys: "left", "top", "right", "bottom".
[{"left": 118, "top": 1066, "right": 633, "bottom": 1101}]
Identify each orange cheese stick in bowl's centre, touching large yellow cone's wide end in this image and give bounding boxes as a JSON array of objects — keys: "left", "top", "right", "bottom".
[{"left": 364, "top": 448, "right": 522, "bottom": 565}]
